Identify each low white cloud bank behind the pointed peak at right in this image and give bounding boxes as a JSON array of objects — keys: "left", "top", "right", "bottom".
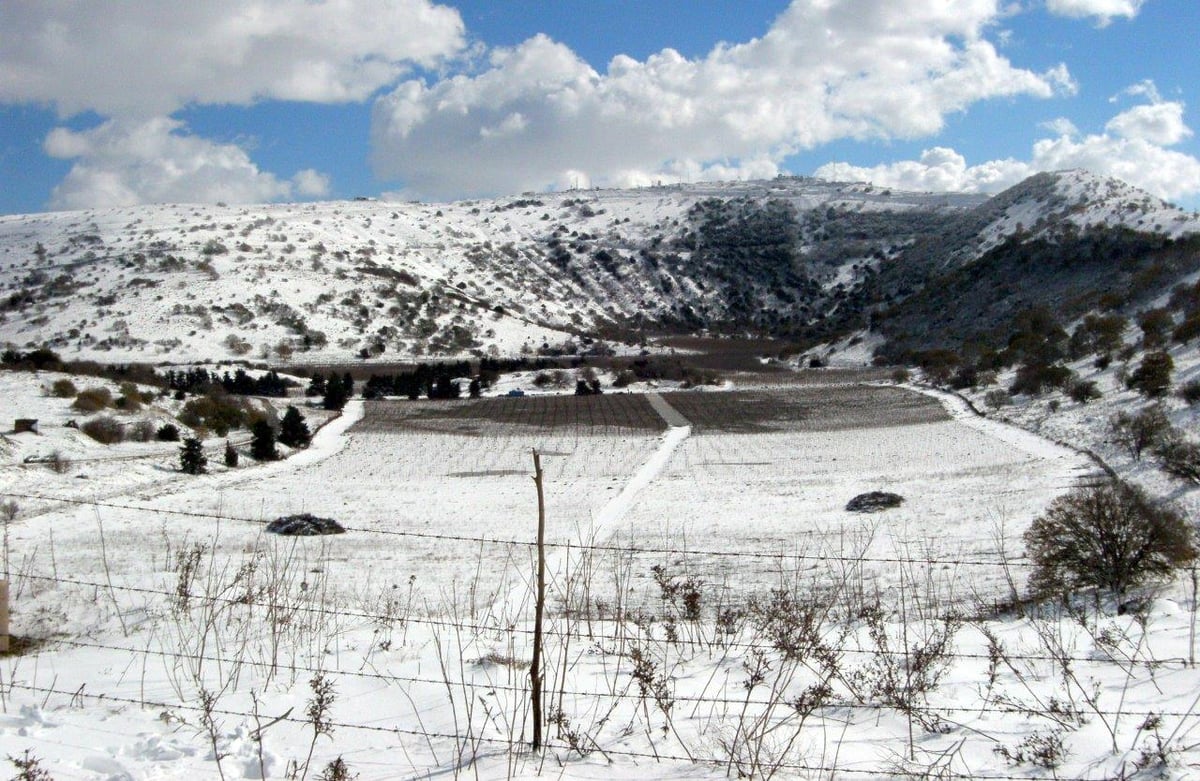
[{"left": 815, "top": 95, "right": 1200, "bottom": 199}]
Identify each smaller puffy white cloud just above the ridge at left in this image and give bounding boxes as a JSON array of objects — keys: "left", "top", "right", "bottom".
[{"left": 43, "top": 118, "right": 329, "bottom": 209}]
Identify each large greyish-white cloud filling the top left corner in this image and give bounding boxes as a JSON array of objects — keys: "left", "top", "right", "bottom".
[{"left": 0, "top": 0, "right": 464, "bottom": 116}]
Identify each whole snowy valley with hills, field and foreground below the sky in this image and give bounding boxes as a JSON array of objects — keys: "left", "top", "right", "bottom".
[{"left": 0, "top": 172, "right": 1200, "bottom": 779}]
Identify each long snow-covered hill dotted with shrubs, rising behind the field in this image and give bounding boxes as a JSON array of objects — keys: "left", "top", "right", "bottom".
[{"left": 0, "top": 172, "right": 1200, "bottom": 362}]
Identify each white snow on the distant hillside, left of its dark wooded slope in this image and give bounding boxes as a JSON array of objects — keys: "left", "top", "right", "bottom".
[{"left": 0, "top": 178, "right": 980, "bottom": 364}]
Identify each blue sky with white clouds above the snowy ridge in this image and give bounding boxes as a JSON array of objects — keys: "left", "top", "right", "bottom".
[{"left": 0, "top": 0, "right": 1200, "bottom": 214}]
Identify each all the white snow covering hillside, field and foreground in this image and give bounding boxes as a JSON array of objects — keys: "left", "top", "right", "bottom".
[{"left": 0, "top": 172, "right": 1200, "bottom": 781}]
